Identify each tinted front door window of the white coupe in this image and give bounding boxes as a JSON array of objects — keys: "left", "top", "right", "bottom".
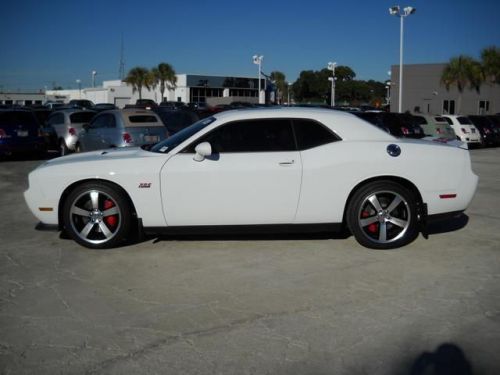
[{"left": 188, "top": 119, "right": 296, "bottom": 153}]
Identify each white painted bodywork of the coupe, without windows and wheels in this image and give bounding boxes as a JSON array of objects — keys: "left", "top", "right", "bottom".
[{"left": 25, "top": 108, "right": 478, "bottom": 231}]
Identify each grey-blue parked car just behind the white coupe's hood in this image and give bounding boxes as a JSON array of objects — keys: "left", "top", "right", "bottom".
[{"left": 76, "top": 109, "right": 168, "bottom": 152}]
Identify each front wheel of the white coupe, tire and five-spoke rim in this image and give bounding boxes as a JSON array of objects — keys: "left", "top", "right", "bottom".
[{"left": 63, "top": 182, "right": 133, "bottom": 249}]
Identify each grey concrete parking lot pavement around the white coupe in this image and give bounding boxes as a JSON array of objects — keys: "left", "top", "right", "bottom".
[{"left": 0, "top": 148, "right": 500, "bottom": 374}]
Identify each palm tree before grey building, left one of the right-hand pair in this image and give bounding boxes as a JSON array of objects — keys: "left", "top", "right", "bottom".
[{"left": 441, "top": 55, "right": 484, "bottom": 113}]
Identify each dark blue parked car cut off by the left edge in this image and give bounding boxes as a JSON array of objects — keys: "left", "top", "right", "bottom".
[{"left": 0, "top": 109, "right": 46, "bottom": 156}]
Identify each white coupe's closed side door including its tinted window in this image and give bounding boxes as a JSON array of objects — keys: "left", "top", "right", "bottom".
[{"left": 161, "top": 119, "right": 302, "bottom": 226}]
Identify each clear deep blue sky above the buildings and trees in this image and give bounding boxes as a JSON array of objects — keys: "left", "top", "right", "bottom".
[{"left": 0, "top": 0, "right": 500, "bottom": 91}]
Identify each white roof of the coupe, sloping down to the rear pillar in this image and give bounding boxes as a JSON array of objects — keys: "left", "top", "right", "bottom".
[{"left": 213, "top": 107, "right": 396, "bottom": 141}]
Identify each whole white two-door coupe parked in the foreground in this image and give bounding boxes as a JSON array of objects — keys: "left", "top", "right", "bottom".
[{"left": 25, "top": 108, "right": 478, "bottom": 249}]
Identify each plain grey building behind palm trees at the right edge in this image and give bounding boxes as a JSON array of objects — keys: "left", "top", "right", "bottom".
[{"left": 390, "top": 64, "right": 500, "bottom": 115}]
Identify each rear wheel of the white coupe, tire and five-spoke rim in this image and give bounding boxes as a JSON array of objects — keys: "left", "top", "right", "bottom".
[{"left": 346, "top": 181, "right": 419, "bottom": 249}]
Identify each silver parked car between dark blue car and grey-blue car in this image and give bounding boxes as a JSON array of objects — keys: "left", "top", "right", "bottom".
[{"left": 47, "top": 108, "right": 95, "bottom": 156}]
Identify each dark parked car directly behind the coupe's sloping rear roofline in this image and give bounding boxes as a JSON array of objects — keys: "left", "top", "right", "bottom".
[{"left": 352, "top": 112, "right": 425, "bottom": 139}]
